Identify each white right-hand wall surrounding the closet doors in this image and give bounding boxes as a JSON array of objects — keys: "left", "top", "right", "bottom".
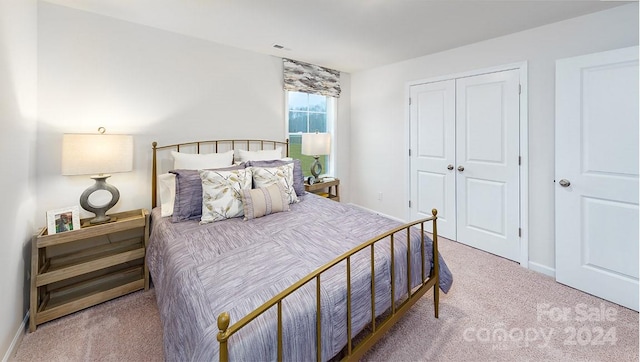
[{"left": 351, "top": 3, "right": 638, "bottom": 269}]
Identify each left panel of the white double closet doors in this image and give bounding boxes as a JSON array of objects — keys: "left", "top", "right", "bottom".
[{"left": 410, "top": 80, "right": 456, "bottom": 240}]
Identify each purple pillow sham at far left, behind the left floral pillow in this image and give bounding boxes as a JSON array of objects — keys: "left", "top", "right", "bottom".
[{"left": 169, "top": 164, "right": 245, "bottom": 222}]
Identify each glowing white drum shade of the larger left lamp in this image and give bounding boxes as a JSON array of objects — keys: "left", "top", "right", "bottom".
[{"left": 62, "top": 134, "right": 133, "bottom": 175}]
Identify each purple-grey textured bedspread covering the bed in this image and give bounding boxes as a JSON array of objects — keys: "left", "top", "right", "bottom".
[{"left": 147, "top": 194, "right": 453, "bottom": 361}]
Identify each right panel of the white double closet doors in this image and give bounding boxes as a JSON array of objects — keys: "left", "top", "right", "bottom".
[{"left": 456, "top": 70, "right": 520, "bottom": 261}]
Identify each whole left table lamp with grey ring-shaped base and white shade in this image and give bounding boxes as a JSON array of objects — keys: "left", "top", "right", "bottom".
[{"left": 62, "top": 127, "right": 133, "bottom": 224}]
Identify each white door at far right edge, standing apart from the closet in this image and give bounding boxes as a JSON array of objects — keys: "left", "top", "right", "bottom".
[{"left": 555, "top": 47, "right": 639, "bottom": 311}]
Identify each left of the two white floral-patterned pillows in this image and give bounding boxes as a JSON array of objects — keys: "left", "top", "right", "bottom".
[{"left": 199, "top": 169, "right": 251, "bottom": 224}]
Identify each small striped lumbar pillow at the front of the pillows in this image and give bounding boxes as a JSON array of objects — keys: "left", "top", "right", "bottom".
[{"left": 240, "top": 183, "right": 289, "bottom": 220}]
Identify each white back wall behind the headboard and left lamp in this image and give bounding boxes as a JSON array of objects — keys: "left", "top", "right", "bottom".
[{"left": 36, "top": 2, "right": 349, "bottom": 223}]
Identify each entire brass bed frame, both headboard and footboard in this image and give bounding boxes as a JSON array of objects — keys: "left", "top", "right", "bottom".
[{"left": 151, "top": 140, "right": 440, "bottom": 362}]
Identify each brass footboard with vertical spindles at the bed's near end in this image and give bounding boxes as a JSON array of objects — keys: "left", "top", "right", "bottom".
[{"left": 218, "top": 209, "right": 440, "bottom": 362}]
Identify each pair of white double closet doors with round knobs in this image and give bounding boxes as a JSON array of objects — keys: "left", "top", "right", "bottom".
[{"left": 410, "top": 70, "right": 520, "bottom": 261}]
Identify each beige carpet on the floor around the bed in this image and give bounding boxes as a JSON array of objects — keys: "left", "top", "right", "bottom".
[{"left": 14, "top": 240, "right": 638, "bottom": 362}]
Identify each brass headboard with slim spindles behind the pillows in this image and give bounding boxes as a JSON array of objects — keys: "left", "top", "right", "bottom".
[{"left": 151, "top": 140, "right": 289, "bottom": 208}]
